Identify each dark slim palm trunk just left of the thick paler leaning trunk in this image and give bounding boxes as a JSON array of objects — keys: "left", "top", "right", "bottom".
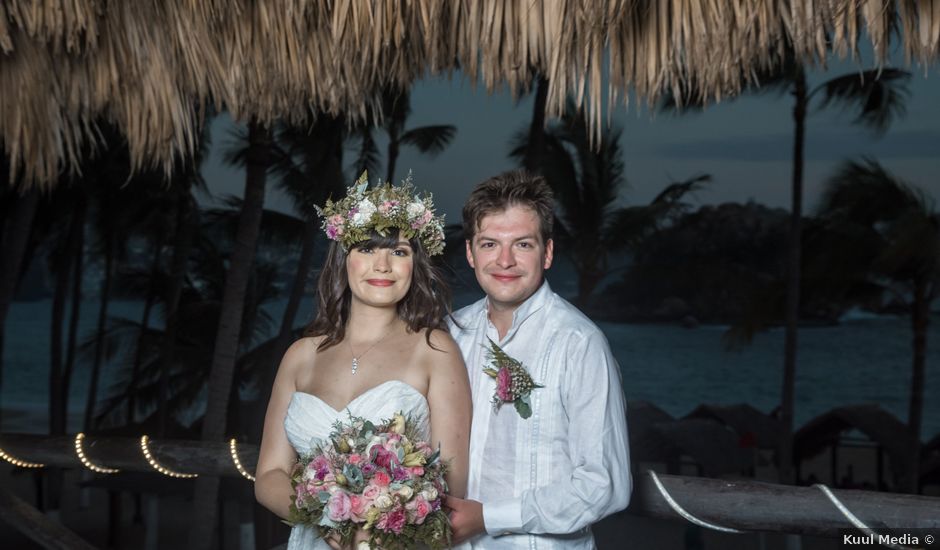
[{"left": 157, "top": 196, "right": 197, "bottom": 436}]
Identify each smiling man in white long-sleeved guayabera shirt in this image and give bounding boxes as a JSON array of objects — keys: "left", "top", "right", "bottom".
[{"left": 447, "top": 171, "right": 631, "bottom": 549}]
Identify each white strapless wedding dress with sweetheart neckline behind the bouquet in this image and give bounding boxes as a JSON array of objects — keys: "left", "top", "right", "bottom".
[{"left": 284, "top": 380, "right": 444, "bottom": 550}]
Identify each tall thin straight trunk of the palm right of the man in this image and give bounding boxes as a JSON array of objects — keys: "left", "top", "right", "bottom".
[{"left": 777, "top": 68, "right": 806, "bottom": 483}]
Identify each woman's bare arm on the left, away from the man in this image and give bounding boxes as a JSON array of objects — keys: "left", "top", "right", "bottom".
[{"left": 255, "top": 338, "right": 312, "bottom": 519}]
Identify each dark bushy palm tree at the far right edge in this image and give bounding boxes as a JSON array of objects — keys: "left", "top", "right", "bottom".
[{"left": 813, "top": 159, "right": 940, "bottom": 493}]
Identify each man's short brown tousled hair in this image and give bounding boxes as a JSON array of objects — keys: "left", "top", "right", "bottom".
[{"left": 463, "top": 169, "right": 555, "bottom": 244}]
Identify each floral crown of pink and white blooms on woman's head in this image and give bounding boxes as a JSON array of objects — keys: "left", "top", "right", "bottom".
[{"left": 316, "top": 172, "right": 444, "bottom": 256}]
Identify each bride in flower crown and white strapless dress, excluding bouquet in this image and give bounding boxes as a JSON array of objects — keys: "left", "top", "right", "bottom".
[{"left": 255, "top": 178, "right": 471, "bottom": 550}]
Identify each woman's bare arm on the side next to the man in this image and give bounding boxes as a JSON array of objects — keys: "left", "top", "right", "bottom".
[{"left": 426, "top": 330, "right": 473, "bottom": 498}]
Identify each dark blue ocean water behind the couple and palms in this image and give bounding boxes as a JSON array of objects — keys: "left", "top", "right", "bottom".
[{"left": 0, "top": 294, "right": 940, "bottom": 441}]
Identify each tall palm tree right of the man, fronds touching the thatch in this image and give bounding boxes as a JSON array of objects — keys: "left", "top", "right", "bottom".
[{"left": 663, "top": 52, "right": 910, "bottom": 483}]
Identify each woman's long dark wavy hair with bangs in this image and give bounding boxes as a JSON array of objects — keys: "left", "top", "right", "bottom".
[{"left": 304, "top": 228, "right": 452, "bottom": 350}]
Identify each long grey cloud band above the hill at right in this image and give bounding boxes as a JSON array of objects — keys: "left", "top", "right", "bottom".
[{"left": 653, "top": 128, "right": 940, "bottom": 162}]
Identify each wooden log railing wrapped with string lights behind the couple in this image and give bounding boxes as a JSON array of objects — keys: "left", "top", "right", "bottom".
[{"left": 0, "top": 434, "right": 940, "bottom": 548}]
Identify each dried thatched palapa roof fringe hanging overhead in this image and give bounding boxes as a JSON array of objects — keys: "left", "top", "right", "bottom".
[{"left": 0, "top": 0, "right": 940, "bottom": 188}]
